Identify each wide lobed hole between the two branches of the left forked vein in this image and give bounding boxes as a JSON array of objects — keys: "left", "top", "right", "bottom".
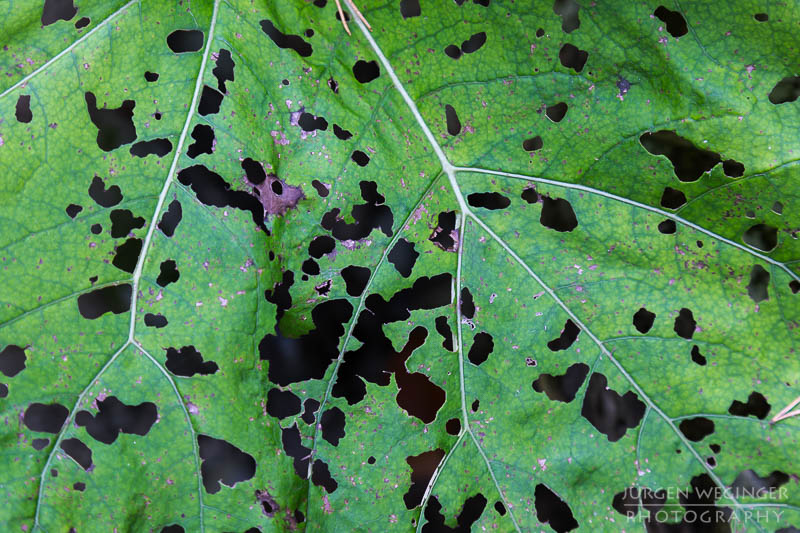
[{"left": 75, "top": 396, "right": 158, "bottom": 444}]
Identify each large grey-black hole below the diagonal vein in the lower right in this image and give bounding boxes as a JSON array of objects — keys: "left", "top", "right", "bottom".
[{"left": 581, "top": 372, "right": 645, "bottom": 442}]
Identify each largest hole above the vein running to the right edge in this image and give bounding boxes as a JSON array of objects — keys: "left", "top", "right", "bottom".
[{"left": 639, "top": 130, "right": 720, "bottom": 182}]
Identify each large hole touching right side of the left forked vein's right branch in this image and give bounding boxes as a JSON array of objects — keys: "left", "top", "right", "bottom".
[{"left": 197, "top": 435, "right": 256, "bottom": 494}]
